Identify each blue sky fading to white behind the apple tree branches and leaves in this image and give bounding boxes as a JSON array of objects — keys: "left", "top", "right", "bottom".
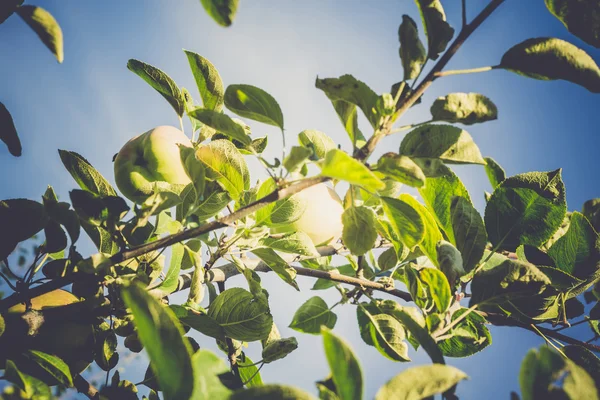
[{"left": 0, "top": 0, "right": 600, "bottom": 399}]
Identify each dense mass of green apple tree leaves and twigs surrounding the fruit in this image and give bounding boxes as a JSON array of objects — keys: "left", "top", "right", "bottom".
[{"left": 0, "top": 0, "right": 600, "bottom": 400}]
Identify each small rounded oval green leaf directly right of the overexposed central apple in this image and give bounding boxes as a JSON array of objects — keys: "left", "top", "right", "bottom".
[{"left": 342, "top": 206, "right": 377, "bottom": 256}]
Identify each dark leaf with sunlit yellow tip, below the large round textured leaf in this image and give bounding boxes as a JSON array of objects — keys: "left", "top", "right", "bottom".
[{"left": 469, "top": 259, "right": 550, "bottom": 306}]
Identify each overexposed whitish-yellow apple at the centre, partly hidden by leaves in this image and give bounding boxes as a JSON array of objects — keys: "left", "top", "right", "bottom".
[{"left": 271, "top": 183, "right": 344, "bottom": 246}]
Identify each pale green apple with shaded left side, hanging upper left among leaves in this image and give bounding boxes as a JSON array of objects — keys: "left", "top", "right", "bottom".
[{"left": 114, "top": 126, "right": 192, "bottom": 204}]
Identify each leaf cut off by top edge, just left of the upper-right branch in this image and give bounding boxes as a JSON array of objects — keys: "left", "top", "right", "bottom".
[{"left": 415, "top": 0, "right": 454, "bottom": 60}]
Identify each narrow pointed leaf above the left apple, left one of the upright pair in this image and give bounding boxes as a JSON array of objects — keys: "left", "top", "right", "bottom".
[{"left": 127, "top": 58, "right": 186, "bottom": 117}]
